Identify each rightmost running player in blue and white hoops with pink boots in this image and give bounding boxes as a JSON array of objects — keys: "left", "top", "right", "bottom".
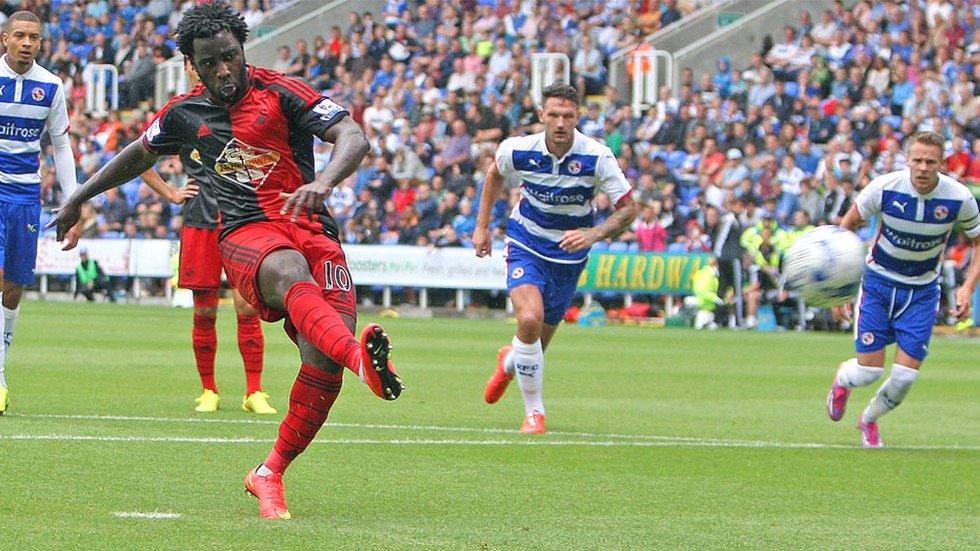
[{"left": 827, "top": 132, "right": 980, "bottom": 448}]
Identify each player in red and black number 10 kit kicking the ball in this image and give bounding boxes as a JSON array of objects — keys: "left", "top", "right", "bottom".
[{"left": 53, "top": 2, "right": 403, "bottom": 518}]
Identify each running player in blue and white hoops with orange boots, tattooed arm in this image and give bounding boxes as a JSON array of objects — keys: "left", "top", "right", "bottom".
[{"left": 473, "top": 84, "right": 636, "bottom": 434}]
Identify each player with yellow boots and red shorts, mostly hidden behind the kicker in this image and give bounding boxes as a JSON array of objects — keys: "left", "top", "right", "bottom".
[{"left": 140, "top": 57, "right": 278, "bottom": 415}]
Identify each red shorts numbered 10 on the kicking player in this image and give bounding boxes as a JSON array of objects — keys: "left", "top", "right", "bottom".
[{"left": 220, "top": 221, "right": 357, "bottom": 322}]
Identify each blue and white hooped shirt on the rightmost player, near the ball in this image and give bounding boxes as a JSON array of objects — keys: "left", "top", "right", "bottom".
[{"left": 855, "top": 169, "right": 980, "bottom": 285}]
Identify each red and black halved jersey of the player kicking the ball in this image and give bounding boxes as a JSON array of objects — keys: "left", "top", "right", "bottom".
[{"left": 143, "top": 65, "right": 348, "bottom": 238}]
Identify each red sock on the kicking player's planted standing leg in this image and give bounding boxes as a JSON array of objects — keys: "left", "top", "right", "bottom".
[{"left": 264, "top": 363, "right": 344, "bottom": 473}]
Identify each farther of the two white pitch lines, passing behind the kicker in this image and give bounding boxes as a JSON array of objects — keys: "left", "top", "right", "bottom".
[{"left": 8, "top": 413, "right": 728, "bottom": 442}]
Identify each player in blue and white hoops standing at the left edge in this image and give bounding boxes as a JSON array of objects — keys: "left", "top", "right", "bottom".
[{"left": 0, "top": 11, "right": 80, "bottom": 415}]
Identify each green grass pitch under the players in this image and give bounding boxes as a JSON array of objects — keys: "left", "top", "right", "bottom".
[{"left": 0, "top": 302, "right": 980, "bottom": 549}]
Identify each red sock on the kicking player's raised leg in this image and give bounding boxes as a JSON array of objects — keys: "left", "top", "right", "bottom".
[{"left": 283, "top": 281, "right": 361, "bottom": 373}]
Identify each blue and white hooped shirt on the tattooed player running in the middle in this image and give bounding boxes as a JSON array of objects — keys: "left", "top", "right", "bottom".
[{"left": 497, "top": 130, "right": 630, "bottom": 264}]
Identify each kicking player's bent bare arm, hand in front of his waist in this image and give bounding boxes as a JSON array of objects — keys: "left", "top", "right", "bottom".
[{"left": 279, "top": 117, "right": 371, "bottom": 222}]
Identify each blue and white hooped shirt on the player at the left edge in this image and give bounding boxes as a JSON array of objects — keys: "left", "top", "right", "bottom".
[{"left": 0, "top": 55, "right": 68, "bottom": 205}]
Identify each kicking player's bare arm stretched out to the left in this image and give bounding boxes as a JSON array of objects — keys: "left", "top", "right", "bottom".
[{"left": 47, "top": 141, "right": 159, "bottom": 248}]
